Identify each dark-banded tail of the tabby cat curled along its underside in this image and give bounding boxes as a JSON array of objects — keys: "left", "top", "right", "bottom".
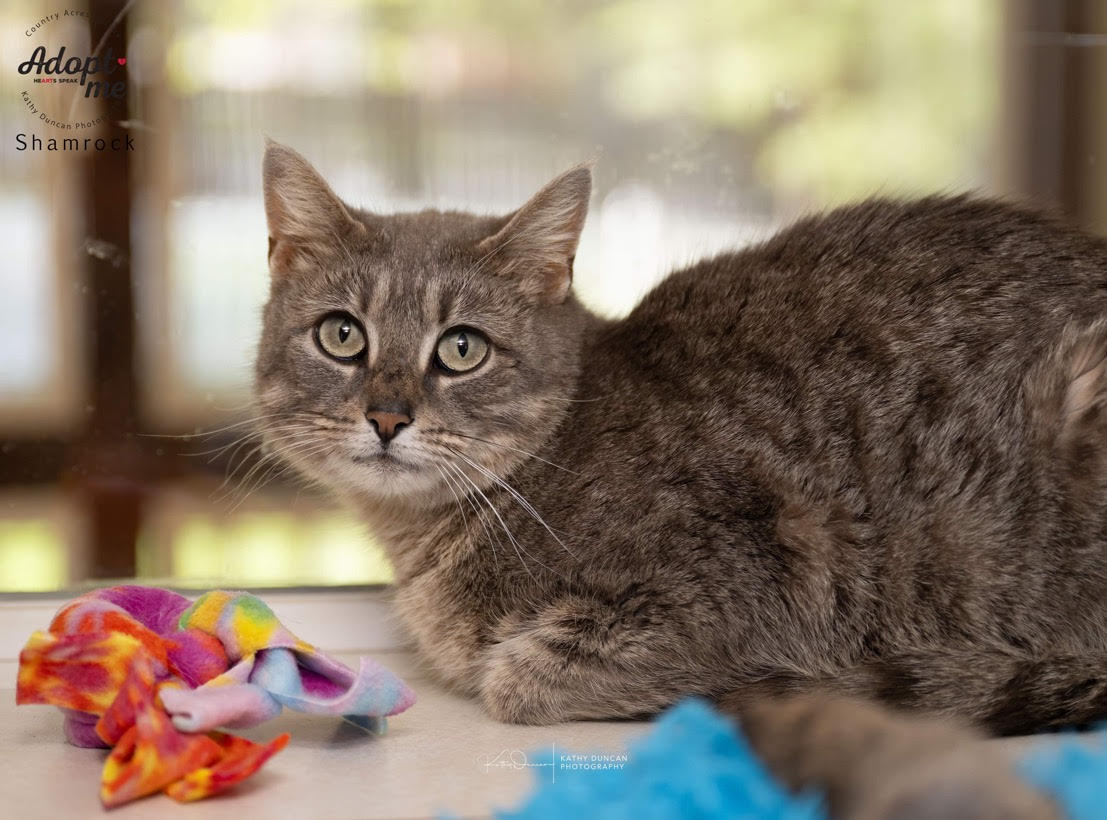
[{"left": 720, "top": 647, "right": 1107, "bottom": 735}]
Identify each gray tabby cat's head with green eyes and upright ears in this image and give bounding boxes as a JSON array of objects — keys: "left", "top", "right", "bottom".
[{"left": 256, "top": 143, "right": 591, "bottom": 500}]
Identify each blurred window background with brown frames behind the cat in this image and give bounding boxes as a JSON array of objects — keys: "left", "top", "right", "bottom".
[{"left": 0, "top": 0, "right": 1107, "bottom": 592}]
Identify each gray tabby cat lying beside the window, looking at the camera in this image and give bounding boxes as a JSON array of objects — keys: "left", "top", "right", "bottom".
[{"left": 257, "top": 138, "right": 1107, "bottom": 817}]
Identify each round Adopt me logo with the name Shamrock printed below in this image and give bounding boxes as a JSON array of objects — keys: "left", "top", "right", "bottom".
[{"left": 15, "top": 9, "right": 134, "bottom": 150}]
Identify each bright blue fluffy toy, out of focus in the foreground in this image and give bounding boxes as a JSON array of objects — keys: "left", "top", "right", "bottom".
[{"left": 496, "top": 699, "right": 1107, "bottom": 820}]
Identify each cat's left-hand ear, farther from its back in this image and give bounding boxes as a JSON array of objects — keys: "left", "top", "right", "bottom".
[{"left": 261, "top": 138, "right": 366, "bottom": 274}]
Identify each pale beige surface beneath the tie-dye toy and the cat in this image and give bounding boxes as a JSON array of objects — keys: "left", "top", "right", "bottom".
[{"left": 0, "top": 651, "right": 1089, "bottom": 820}]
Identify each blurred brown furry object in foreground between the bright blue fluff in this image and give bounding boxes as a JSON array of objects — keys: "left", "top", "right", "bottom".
[{"left": 738, "top": 694, "right": 1061, "bottom": 820}]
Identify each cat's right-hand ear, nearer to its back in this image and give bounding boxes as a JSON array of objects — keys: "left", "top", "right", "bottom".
[{"left": 478, "top": 165, "right": 592, "bottom": 304}]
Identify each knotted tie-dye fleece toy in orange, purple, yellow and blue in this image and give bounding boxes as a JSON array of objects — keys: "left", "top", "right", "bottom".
[{"left": 15, "top": 587, "right": 415, "bottom": 807}]
